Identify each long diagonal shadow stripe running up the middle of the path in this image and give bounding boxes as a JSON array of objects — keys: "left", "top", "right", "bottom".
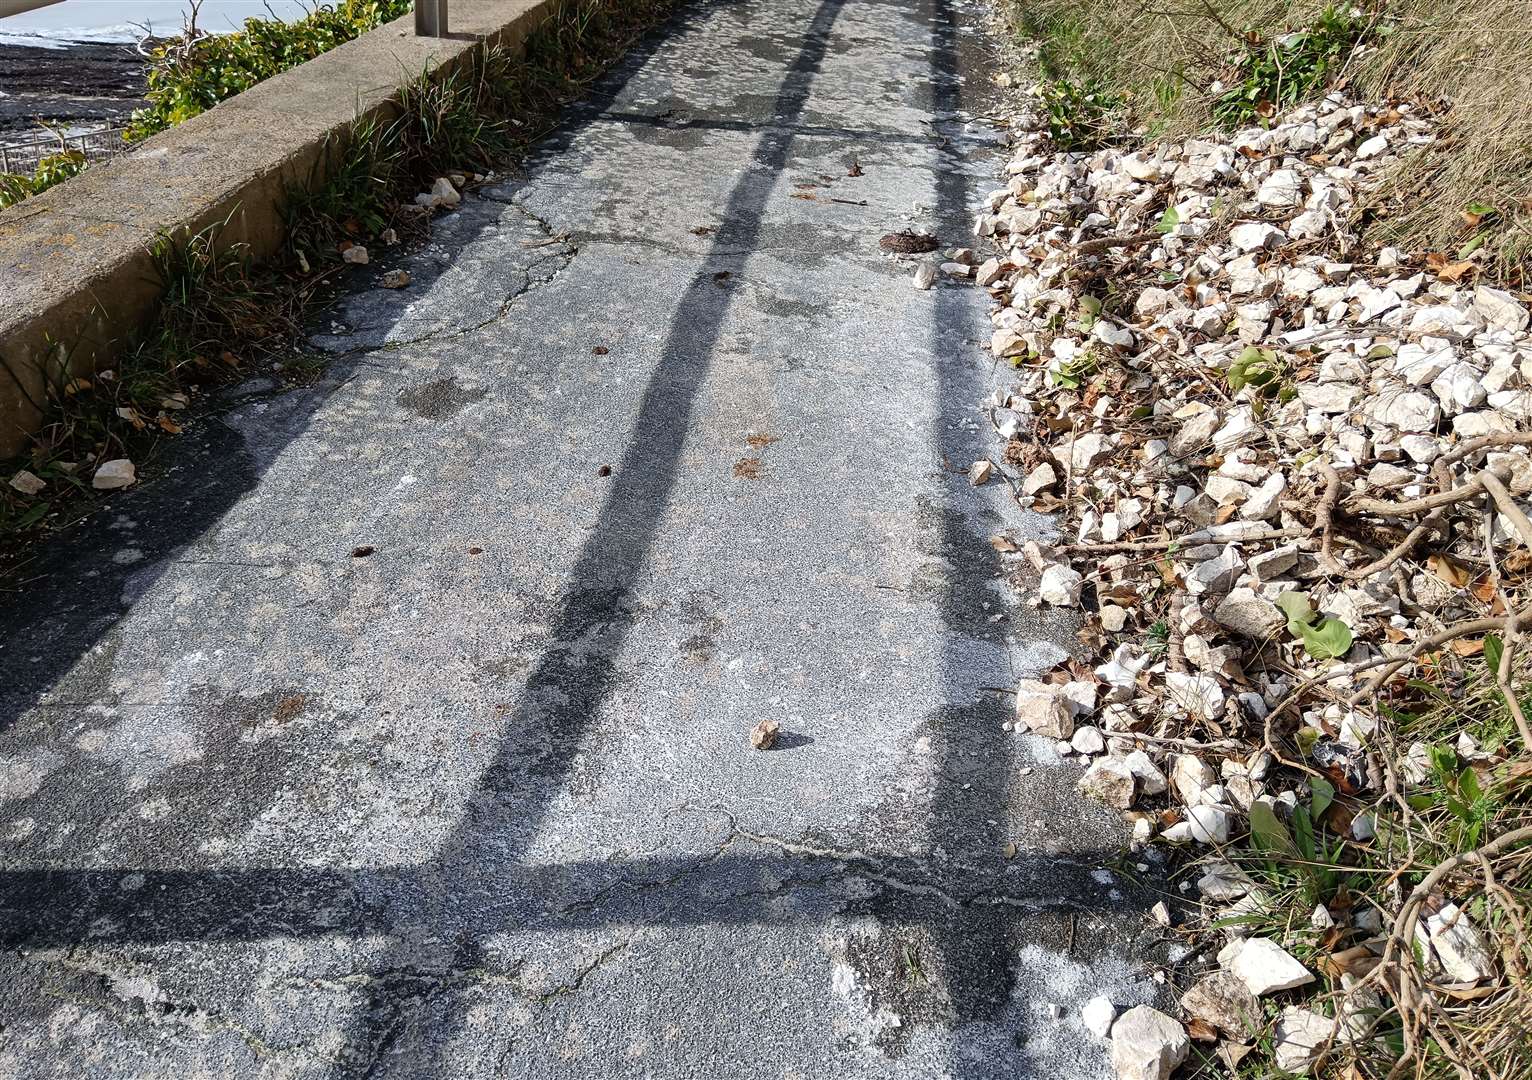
[{"left": 333, "top": 0, "right": 864, "bottom": 1074}]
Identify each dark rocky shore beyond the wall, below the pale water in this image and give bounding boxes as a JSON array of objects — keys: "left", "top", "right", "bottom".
[{"left": 0, "top": 41, "right": 147, "bottom": 142}]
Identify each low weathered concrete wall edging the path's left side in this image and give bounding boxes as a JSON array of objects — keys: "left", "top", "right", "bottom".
[{"left": 0, "top": 0, "right": 564, "bottom": 457}]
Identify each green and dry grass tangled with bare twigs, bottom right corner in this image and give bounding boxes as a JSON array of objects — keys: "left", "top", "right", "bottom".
[{"left": 1201, "top": 636, "right": 1532, "bottom": 1080}]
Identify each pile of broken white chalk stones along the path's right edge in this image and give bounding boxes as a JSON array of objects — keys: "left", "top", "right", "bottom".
[{"left": 915, "top": 95, "right": 1532, "bottom": 1080}]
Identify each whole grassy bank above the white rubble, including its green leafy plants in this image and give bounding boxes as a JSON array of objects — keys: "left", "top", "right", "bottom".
[{"left": 1008, "top": 0, "right": 1532, "bottom": 285}]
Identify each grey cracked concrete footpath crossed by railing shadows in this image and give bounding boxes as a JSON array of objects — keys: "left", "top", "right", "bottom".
[{"left": 0, "top": 0, "right": 1155, "bottom": 1080}]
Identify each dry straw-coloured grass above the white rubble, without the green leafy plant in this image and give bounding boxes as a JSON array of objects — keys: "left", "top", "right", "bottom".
[{"left": 1008, "top": 0, "right": 1532, "bottom": 285}]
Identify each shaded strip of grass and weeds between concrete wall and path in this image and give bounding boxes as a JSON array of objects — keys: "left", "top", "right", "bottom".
[{"left": 0, "top": 0, "right": 669, "bottom": 574}]
